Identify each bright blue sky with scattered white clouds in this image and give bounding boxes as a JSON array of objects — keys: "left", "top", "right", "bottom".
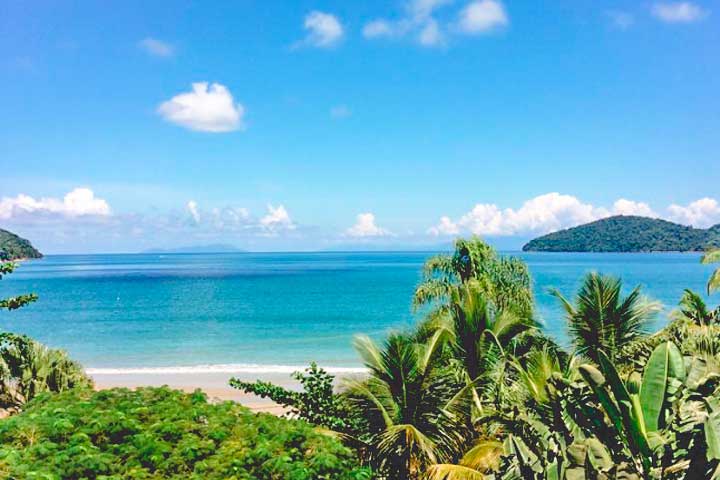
[{"left": 0, "top": 0, "right": 720, "bottom": 253}]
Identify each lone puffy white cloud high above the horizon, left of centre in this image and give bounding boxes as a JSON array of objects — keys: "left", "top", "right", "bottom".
[{"left": 158, "top": 82, "right": 245, "bottom": 132}]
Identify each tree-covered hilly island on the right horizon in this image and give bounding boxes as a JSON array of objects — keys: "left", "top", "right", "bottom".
[{"left": 523, "top": 215, "right": 720, "bottom": 252}]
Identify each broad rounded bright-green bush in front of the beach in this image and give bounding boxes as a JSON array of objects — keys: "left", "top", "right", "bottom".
[{"left": 0, "top": 387, "right": 370, "bottom": 480}]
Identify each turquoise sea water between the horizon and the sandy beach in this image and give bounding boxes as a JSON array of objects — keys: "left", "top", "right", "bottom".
[{"left": 0, "top": 253, "right": 717, "bottom": 371}]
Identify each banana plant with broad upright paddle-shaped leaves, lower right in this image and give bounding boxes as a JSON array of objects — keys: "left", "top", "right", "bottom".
[{"left": 580, "top": 342, "right": 685, "bottom": 476}]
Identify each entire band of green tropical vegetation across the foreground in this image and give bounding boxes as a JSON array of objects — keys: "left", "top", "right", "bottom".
[{"left": 0, "top": 238, "right": 720, "bottom": 480}]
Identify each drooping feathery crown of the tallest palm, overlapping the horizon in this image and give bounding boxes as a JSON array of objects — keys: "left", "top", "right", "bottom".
[{"left": 413, "top": 237, "right": 533, "bottom": 317}]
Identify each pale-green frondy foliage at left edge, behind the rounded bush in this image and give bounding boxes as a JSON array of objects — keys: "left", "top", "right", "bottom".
[{"left": 0, "top": 333, "right": 92, "bottom": 411}]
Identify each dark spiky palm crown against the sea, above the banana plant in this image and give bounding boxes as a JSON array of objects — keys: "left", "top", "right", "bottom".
[{"left": 551, "top": 272, "right": 660, "bottom": 363}]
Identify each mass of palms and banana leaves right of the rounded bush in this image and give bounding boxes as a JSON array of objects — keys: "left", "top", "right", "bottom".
[{"left": 235, "top": 239, "right": 720, "bottom": 480}]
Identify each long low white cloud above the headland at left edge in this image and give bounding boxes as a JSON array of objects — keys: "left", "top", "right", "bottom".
[{"left": 0, "top": 188, "right": 110, "bottom": 220}]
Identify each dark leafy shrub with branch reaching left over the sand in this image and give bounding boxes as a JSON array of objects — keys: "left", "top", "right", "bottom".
[{"left": 230, "top": 362, "right": 361, "bottom": 434}]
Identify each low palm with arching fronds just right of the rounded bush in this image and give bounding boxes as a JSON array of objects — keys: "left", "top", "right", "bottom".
[{"left": 346, "top": 329, "right": 464, "bottom": 479}]
